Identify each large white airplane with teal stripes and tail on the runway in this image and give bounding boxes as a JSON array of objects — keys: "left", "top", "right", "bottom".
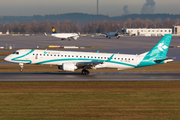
[{"left": 4, "top": 34, "right": 173, "bottom": 75}]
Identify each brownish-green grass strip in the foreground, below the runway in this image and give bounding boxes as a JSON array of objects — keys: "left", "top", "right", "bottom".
[{"left": 0, "top": 81, "right": 180, "bottom": 120}]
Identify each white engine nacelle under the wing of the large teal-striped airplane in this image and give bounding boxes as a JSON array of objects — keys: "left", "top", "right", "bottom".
[{"left": 58, "top": 63, "right": 77, "bottom": 72}]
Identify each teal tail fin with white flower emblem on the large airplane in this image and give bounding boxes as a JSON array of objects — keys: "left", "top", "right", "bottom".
[{"left": 143, "top": 34, "right": 172, "bottom": 60}]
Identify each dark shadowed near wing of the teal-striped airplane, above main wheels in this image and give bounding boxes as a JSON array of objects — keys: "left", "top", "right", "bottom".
[{"left": 76, "top": 61, "right": 104, "bottom": 69}]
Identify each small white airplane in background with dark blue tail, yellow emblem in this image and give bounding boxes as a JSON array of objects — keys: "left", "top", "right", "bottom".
[{"left": 44, "top": 26, "right": 79, "bottom": 40}]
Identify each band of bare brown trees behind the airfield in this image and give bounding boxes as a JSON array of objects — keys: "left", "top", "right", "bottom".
[{"left": 0, "top": 18, "right": 180, "bottom": 34}]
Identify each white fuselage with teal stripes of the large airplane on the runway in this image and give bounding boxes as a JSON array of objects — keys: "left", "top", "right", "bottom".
[{"left": 5, "top": 49, "right": 143, "bottom": 70}]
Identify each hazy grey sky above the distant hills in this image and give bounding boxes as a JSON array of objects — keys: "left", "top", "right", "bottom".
[{"left": 0, "top": 0, "right": 180, "bottom": 17}]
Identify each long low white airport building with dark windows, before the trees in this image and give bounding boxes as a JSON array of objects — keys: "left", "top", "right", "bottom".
[{"left": 122, "top": 26, "right": 180, "bottom": 36}]
